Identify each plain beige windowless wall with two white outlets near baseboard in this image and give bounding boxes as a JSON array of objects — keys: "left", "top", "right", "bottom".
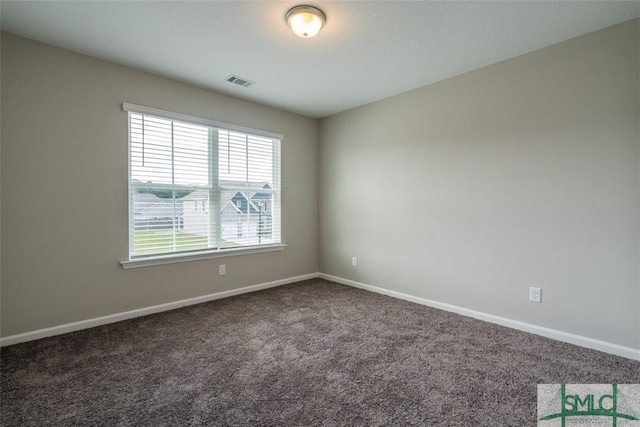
[{"left": 319, "top": 20, "right": 640, "bottom": 348}]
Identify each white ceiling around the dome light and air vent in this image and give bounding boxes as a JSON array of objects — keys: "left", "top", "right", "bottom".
[{"left": 0, "top": 0, "right": 640, "bottom": 118}]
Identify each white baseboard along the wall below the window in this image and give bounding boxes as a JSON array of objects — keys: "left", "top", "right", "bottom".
[{"left": 0, "top": 273, "right": 319, "bottom": 347}]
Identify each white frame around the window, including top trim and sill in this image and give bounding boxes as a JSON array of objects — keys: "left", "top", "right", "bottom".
[{"left": 120, "top": 102, "right": 287, "bottom": 269}]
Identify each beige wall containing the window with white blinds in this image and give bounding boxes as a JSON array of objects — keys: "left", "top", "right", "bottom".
[{"left": 1, "top": 33, "right": 318, "bottom": 336}]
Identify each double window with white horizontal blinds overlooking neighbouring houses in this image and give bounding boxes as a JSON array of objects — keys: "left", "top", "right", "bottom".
[{"left": 123, "top": 104, "right": 282, "bottom": 265}]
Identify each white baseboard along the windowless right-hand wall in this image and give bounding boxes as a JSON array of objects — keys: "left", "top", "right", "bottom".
[{"left": 319, "top": 273, "right": 640, "bottom": 361}]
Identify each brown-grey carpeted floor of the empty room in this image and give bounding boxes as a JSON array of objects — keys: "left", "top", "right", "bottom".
[{"left": 0, "top": 279, "right": 640, "bottom": 427}]
